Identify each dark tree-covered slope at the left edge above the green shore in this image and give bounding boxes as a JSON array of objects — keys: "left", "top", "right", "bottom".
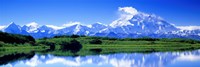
[{"left": 0, "top": 31, "right": 35, "bottom": 44}]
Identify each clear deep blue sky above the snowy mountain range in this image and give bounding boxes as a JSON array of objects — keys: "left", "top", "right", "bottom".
[{"left": 0, "top": 0, "right": 200, "bottom": 26}]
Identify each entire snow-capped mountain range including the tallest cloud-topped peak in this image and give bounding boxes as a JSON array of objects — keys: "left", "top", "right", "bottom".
[{"left": 0, "top": 7, "right": 200, "bottom": 40}]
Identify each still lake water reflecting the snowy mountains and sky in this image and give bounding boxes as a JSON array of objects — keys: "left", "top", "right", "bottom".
[{"left": 0, "top": 50, "right": 200, "bottom": 67}]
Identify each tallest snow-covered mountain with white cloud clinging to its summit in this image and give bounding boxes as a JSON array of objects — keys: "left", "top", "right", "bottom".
[{"left": 110, "top": 7, "right": 178, "bottom": 33}]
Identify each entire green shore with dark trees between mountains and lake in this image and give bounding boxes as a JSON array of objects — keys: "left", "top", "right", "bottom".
[{"left": 0, "top": 32, "right": 200, "bottom": 57}]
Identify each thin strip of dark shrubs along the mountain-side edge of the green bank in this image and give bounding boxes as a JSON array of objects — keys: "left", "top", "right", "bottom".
[{"left": 50, "top": 35, "right": 200, "bottom": 44}]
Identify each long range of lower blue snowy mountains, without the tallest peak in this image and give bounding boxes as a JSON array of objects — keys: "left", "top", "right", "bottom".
[{"left": 1, "top": 22, "right": 200, "bottom": 40}]
